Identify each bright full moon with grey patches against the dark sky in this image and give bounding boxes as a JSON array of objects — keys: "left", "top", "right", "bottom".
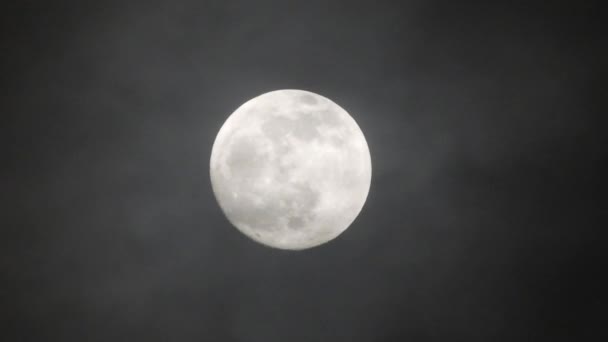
[{"left": 210, "top": 89, "right": 372, "bottom": 250}]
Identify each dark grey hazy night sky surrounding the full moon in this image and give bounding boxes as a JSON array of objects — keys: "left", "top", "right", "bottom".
[{"left": 0, "top": 0, "right": 608, "bottom": 342}]
